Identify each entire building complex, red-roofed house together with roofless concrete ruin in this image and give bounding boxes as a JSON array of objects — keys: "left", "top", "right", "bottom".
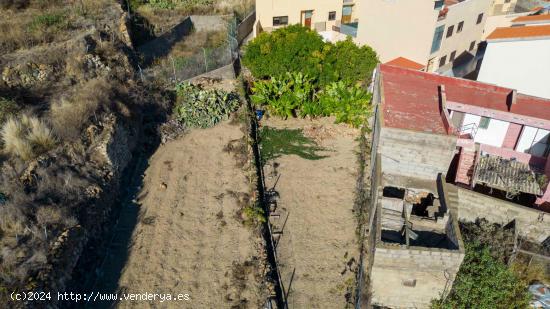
[{"left": 367, "top": 65, "right": 550, "bottom": 308}]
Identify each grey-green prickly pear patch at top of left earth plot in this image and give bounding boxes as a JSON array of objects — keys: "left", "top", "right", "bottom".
[{"left": 174, "top": 83, "right": 240, "bottom": 128}]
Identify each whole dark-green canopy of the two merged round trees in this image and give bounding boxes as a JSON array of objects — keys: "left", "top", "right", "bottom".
[{"left": 243, "top": 25, "right": 378, "bottom": 86}]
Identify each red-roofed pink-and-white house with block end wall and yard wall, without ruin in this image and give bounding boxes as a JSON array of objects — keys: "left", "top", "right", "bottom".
[{"left": 373, "top": 65, "right": 550, "bottom": 243}]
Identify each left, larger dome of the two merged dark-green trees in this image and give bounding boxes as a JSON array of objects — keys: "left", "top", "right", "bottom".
[{"left": 243, "top": 25, "right": 325, "bottom": 79}]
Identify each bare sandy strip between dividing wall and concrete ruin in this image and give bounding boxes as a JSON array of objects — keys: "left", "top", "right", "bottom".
[{"left": 262, "top": 118, "right": 359, "bottom": 309}]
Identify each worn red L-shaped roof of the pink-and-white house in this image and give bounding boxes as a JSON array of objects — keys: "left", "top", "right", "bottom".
[{"left": 380, "top": 64, "right": 550, "bottom": 134}]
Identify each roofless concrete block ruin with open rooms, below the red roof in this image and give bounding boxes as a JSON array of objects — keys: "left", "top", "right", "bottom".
[{"left": 368, "top": 66, "right": 464, "bottom": 308}]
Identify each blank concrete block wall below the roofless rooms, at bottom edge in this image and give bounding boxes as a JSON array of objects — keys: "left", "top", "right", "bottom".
[{"left": 371, "top": 245, "right": 464, "bottom": 308}]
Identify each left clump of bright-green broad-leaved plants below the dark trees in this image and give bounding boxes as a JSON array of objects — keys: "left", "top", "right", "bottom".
[{"left": 250, "top": 72, "right": 314, "bottom": 118}]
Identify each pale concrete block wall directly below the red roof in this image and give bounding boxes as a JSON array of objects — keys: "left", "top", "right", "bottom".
[{"left": 378, "top": 127, "right": 456, "bottom": 180}]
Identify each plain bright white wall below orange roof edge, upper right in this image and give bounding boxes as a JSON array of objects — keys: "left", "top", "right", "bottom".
[{"left": 478, "top": 38, "right": 550, "bottom": 99}]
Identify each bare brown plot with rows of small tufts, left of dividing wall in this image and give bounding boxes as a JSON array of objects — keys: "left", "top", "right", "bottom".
[{"left": 119, "top": 122, "right": 265, "bottom": 309}]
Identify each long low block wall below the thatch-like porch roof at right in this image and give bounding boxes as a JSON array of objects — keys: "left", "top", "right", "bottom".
[{"left": 458, "top": 188, "right": 550, "bottom": 243}]
